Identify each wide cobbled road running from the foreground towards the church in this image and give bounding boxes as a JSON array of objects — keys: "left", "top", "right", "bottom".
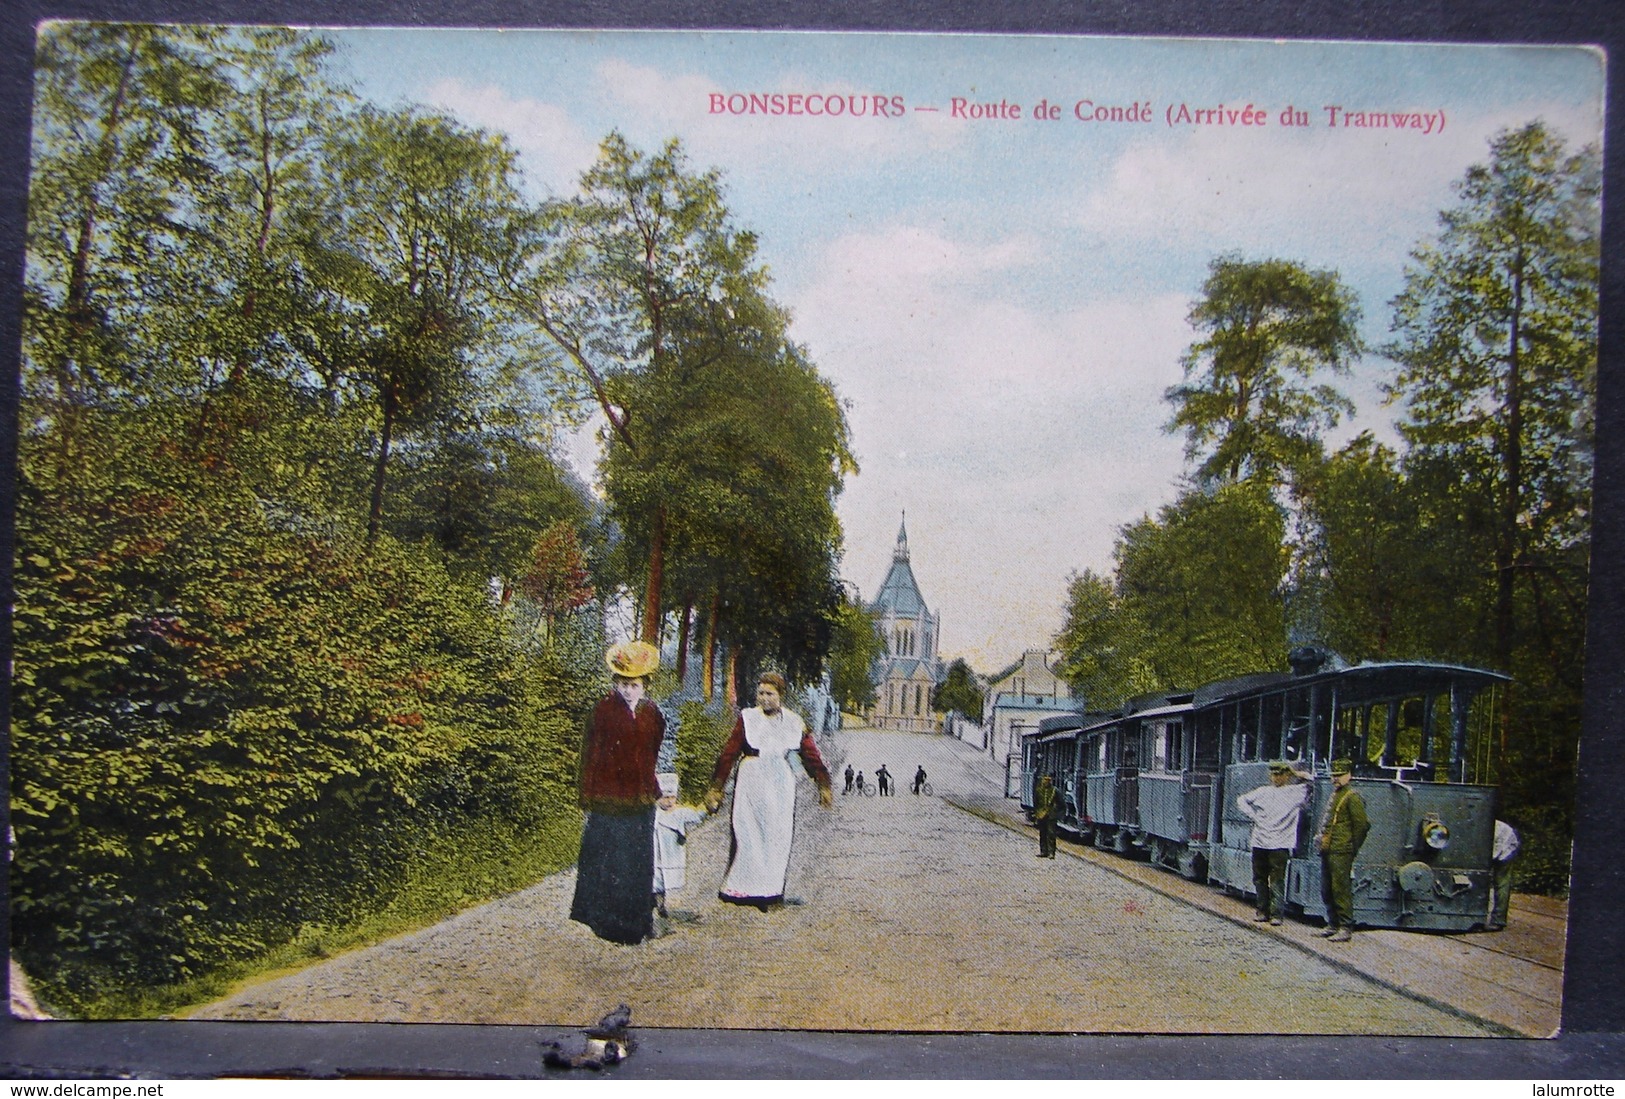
[{"left": 190, "top": 730, "right": 1493, "bottom": 1036}]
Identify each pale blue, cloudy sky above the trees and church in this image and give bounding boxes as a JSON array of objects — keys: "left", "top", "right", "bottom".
[{"left": 335, "top": 29, "right": 1604, "bottom": 673}]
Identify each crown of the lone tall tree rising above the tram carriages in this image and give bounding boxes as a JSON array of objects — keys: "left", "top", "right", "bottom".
[{"left": 1167, "top": 255, "right": 1360, "bottom": 481}]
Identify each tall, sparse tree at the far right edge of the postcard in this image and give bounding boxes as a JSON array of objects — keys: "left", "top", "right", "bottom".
[{"left": 1388, "top": 122, "right": 1601, "bottom": 668}]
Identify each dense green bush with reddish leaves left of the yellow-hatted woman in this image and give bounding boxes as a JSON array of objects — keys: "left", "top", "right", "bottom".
[{"left": 11, "top": 419, "right": 587, "bottom": 1005}]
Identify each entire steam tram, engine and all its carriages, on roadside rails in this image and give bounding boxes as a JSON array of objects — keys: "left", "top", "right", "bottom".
[{"left": 1022, "top": 649, "right": 1506, "bottom": 932}]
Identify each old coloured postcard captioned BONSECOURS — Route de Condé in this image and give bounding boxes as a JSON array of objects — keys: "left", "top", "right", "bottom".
[{"left": 10, "top": 21, "right": 1604, "bottom": 1040}]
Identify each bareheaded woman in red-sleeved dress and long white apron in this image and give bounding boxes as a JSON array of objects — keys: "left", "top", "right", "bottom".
[{"left": 705, "top": 671, "right": 835, "bottom": 912}]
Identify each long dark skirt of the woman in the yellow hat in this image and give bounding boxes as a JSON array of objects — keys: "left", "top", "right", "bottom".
[{"left": 570, "top": 805, "right": 655, "bottom": 943}]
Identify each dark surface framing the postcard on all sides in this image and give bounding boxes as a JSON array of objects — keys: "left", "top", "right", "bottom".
[{"left": 0, "top": 0, "right": 1625, "bottom": 1079}]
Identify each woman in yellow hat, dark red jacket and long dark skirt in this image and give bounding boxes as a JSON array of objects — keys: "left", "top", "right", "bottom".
[{"left": 570, "top": 641, "right": 666, "bottom": 945}]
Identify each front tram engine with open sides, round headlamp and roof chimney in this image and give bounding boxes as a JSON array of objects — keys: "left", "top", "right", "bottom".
[{"left": 1194, "top": 650, "right": 1506, "bottom": 932}]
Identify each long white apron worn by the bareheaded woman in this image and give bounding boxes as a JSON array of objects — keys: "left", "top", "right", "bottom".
[{"left": 722, "top": 707, "right": 806, "bottom": 901}]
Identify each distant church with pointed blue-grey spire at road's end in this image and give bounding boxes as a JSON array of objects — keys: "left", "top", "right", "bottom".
[{"left": 868, "top": 515, "right": 946, "bottom": 733}]
